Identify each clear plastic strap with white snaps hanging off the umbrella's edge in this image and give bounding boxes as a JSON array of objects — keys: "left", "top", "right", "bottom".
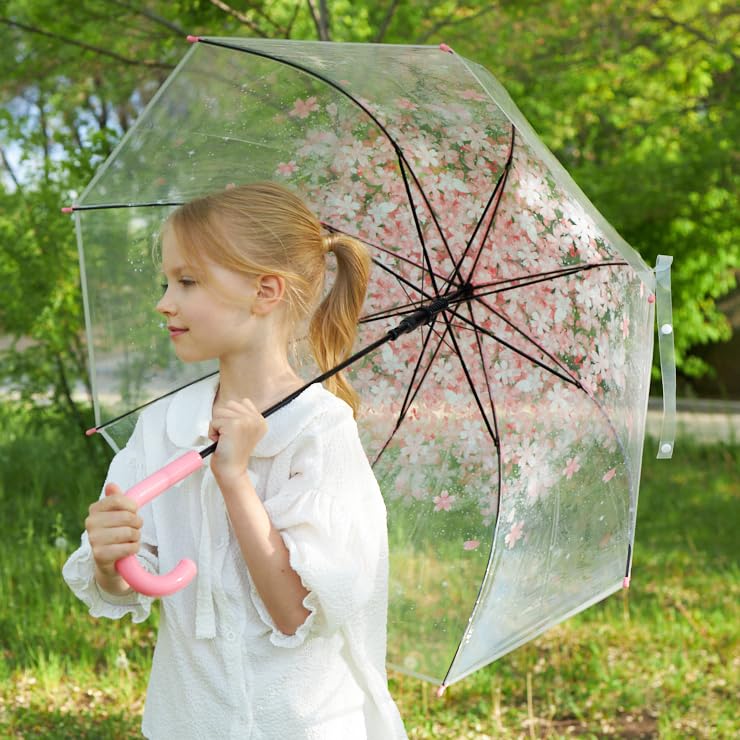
[{"left": 655, "top": 254, "right": 676, "bottom": 459}]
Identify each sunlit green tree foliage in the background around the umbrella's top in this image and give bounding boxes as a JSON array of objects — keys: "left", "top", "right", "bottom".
[{"left": 0, "top": 0, "right": 740, "bottom": 440}]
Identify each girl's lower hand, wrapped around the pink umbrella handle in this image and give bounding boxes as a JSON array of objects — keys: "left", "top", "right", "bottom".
[{"left": 85, "top": 483, "right": 144, "bottom": 592}]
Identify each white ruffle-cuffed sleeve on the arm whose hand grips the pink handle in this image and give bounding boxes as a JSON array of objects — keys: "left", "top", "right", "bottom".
[{"left": 62, "top": 426, "right": 158, "bottom": 622}]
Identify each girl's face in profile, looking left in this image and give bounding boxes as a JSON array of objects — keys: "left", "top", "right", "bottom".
[{"left": 156, "top": 229, "right": 257, "bottom": 362}]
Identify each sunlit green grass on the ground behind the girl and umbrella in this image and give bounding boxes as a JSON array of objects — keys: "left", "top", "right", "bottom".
[{"left": 0, "top": 402, "right": 740, "bottom": 739}]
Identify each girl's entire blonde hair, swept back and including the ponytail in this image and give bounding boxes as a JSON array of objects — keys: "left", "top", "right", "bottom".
[{"left": 165, "top": 182, "right": 370, "bottom": 415}]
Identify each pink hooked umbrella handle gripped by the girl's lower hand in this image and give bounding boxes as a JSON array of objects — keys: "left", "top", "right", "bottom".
[{"left": 116, "top": 450, "right": 203, "bottom": 596}]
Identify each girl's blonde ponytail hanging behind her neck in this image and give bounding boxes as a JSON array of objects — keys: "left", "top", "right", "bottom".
[{"left": 308, "top": 234, "right": 370, "bottom": 416}]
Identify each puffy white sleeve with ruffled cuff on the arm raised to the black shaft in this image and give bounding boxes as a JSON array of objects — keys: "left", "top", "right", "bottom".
[{"left": 251, "top": 414, "right": 387, "bottom": 648}]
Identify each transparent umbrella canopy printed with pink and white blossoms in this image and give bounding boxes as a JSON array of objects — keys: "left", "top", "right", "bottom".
[{"left": 68, "top": 38, "right": 656, "bottom": 684}]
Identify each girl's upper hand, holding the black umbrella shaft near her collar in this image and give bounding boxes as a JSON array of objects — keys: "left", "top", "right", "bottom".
[{"left": 208, "top": 398, "right": 267, "bottom": 493}]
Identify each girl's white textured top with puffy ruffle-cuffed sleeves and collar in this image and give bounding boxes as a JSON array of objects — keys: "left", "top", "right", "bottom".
[{"left": 63, "top": 379, "right": 406, "bottom": 740}]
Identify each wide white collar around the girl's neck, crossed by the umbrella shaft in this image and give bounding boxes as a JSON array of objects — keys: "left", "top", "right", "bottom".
[{"left": 165, "top": 375, "right": 334, "bottom": 457}]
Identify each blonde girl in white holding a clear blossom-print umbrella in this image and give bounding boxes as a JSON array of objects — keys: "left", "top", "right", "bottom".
[{"left": 64, "top": 184, "right": 405, "bottom": 740}]
